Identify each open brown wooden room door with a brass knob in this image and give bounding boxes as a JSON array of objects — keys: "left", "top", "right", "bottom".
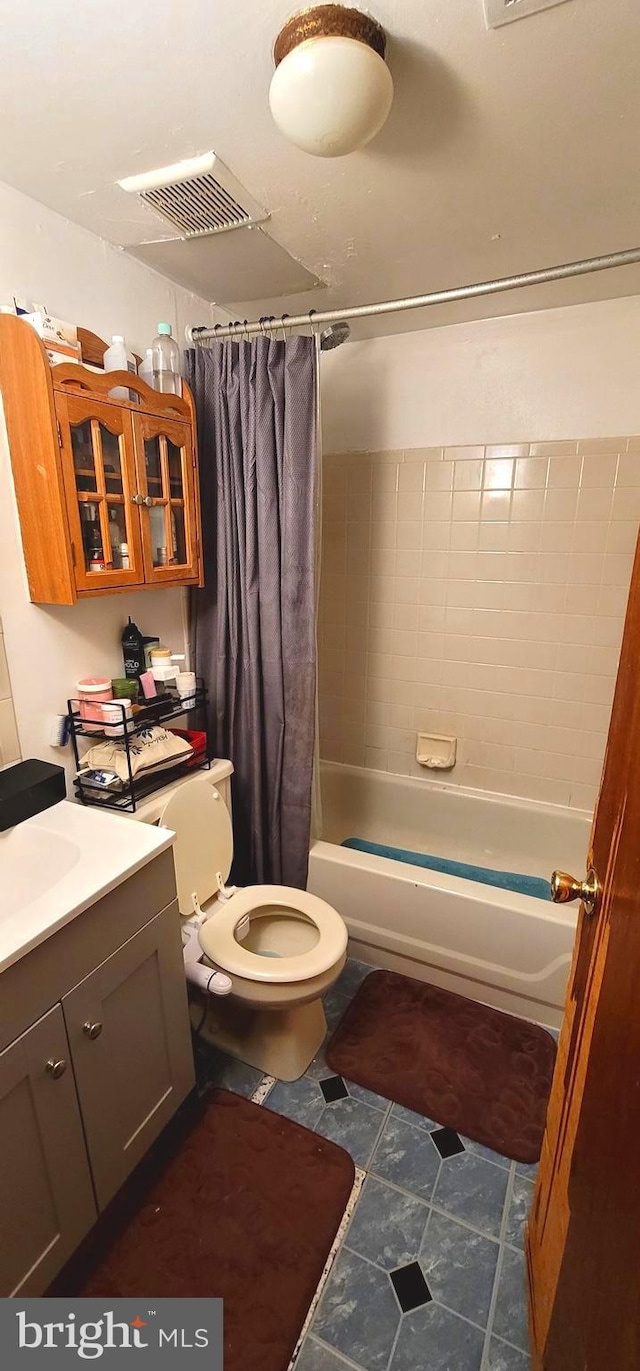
[{"left": 528, "top": 529, "right": 640, "bottom": 1371}]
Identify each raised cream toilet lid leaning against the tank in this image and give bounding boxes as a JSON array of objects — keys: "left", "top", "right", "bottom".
[{"left": 159, "top": 776, "right": 233, "bottom": 916}]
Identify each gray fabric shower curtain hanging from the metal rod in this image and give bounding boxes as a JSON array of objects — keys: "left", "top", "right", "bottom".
[{"left": 186, "top": 337, "right": 317, "bottom": 888}]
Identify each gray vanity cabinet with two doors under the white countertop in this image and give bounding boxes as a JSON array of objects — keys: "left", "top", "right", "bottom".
[{"left": 0, "top": 851, "right": 195, "bottom": 1296}]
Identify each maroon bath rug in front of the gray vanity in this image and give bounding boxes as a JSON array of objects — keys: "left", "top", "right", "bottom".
[{"left": 55, "top": 1090, "right": 355, "bottom": 1371}]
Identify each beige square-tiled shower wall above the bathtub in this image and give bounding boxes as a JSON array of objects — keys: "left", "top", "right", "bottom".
[{"left": 319, "top": 437, "right": 640, "bottom": 808}]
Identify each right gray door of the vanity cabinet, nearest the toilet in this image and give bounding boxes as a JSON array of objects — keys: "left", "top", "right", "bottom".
[{"left": 62, "top": 903, "right": 193, "bottom": 1209}]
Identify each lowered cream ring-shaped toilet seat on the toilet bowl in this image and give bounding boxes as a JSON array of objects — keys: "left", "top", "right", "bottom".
[{"left": 200, "top": 886, "right": 347, "bottom": 983}]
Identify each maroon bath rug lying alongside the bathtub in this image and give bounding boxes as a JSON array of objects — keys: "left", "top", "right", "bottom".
[{"left": 326, "top": 971, "right": 555, "bottom": 1161}]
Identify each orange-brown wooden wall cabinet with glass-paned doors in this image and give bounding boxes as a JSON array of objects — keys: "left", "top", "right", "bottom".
[{"left": 0, "top": 314, "right": 203, "bottom": 605}]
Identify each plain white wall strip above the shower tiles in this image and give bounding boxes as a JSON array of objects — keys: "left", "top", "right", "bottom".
[{"left": 322, "top": 296, "right": 640, "bottom": 452}]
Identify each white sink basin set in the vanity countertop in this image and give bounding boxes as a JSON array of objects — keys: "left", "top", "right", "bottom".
[{"left": 0, "top": 816, "right": 81, "bottom": 913}]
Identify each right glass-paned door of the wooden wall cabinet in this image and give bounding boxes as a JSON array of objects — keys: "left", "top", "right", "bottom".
[{"left": 133, "top": 414, "right": 200, "bottom": 585}]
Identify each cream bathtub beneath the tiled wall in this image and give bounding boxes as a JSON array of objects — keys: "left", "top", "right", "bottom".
[{"left": 308, "top": 762, "right": 591, "bottom": 1027}]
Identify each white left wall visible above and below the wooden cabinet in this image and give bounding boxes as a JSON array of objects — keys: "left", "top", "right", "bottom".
[{"left": 0, "top": 185, "right": 211, "bottom": 766}]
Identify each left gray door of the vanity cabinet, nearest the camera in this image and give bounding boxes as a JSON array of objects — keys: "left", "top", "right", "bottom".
[{"left": 0, "top": 1005, "right": 96, "bottom": 1296}]
